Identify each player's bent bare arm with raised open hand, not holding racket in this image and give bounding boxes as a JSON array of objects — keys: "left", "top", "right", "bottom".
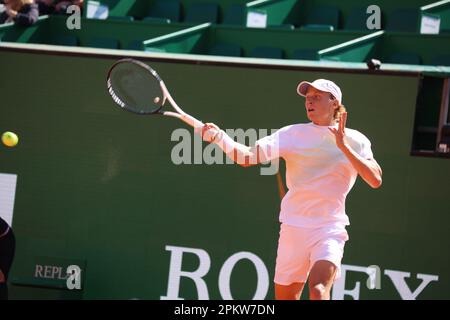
[{"left": 329, "top": 112, "right": 383, "bottom": 189}]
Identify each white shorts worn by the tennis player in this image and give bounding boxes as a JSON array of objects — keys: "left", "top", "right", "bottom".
[{"left": 274, "top": 224, "right": 348, "bottom": 286}]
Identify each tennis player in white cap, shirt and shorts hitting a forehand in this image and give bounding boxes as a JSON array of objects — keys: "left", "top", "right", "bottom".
[{"left": 202, "top": 79, "right": 382, "bottom": 300}]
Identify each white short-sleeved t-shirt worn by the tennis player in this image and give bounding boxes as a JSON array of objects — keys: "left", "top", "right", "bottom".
[{"left": 256, "top": 122, "right": 373, "bottom": 228}]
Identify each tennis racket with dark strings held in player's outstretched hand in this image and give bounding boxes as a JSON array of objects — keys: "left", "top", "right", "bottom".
[{"left": 107, "top": 58, "right": 204, "bottom": 130}]
